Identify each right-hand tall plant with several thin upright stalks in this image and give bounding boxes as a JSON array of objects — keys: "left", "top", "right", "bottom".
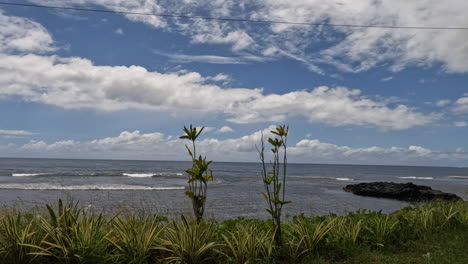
[{"left": 257, "top": 125, "right": 291, "bottom": 247}]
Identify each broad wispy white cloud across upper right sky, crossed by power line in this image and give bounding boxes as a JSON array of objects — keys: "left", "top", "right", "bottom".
[{"left": 28, "top": 0, "right": 468, "bottom": 73}]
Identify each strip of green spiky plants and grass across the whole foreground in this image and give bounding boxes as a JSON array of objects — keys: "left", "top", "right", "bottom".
[{"left": 0, "top": 201, "right": 468, "bottom": 264}]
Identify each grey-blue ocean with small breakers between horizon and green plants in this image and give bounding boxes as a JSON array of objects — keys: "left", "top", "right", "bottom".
[{"left": 0, "top": 158, "right": 468, "bottom": 220}]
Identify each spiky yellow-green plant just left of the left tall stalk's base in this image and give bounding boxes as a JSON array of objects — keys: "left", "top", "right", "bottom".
[{"left": 108, "top": 216, "right": 163, "bottom": 264}]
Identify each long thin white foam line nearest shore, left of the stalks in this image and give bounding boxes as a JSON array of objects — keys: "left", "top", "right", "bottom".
[{"left": 0, "top": 183, "right": 185, "bottom": 191}]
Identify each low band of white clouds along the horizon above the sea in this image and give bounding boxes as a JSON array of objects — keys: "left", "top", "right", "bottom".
[{"left": 4, "top": 126, "right": 468, "bottom": 165}]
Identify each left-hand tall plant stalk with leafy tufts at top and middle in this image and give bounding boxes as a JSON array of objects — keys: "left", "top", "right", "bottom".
[{"left": 179, "top": 125, "right": 213, "bottom": 223}]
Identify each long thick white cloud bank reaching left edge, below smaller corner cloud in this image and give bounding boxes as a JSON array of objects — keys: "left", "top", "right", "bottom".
[{"left": 0, "top": 54, "right": 261, "bottom": 111}]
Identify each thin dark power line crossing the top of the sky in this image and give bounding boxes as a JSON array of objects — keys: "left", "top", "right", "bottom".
[{"left": 0, "top": 2, "right": 468, "bottom": 30}]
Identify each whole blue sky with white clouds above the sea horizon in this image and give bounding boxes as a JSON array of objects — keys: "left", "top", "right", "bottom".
[{"left": 0, "top": 0, "right": 468, "bottom": 167}]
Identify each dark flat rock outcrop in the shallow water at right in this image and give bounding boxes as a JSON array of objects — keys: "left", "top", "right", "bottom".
[{"left": 343, "top": 182, "right": 462, "bottom": 202}]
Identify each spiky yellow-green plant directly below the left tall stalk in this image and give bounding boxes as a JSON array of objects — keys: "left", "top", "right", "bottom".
[{"left": 158, "top": 217, "right": 219, "bottom": 264}]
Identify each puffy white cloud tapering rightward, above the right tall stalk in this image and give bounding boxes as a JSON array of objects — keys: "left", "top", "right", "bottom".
[{"left": 224, "top": 86, "right": 437, "bottom": 130}]
